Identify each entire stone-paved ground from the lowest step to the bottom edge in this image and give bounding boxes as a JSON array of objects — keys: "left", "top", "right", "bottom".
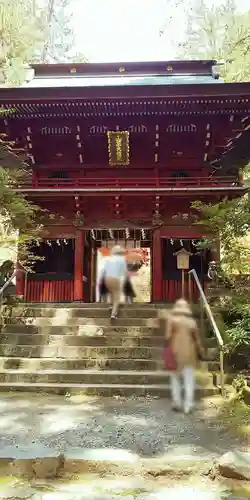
[{"left": 0, "top": 393, "right": 247, "bottom": 500}]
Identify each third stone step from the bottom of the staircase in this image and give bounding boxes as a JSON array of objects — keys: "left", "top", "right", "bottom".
[{"left": 0, "top": 357, "right": 219, "bottom": 372}]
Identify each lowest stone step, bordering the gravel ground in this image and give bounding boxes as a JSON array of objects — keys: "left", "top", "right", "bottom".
[{"left": 0, "top": 382, "right": 219, "bottom": 398}]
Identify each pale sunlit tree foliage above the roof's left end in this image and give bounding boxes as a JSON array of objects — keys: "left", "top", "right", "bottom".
[{"left": 0, "top": 0, "right": 86, "bottom": 86}]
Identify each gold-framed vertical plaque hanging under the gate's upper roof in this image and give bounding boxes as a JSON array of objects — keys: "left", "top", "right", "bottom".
[{"left": 107, "top": 131, "right": 129, "bottom": 166}]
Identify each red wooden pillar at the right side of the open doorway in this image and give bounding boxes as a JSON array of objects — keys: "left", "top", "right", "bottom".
[{"left": 152, "top": 229, "right": 162, "bottom": 302}]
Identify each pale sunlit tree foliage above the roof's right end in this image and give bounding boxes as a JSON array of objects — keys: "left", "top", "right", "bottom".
[{"left": 179, "top": 0, "right": 250, "bottom": 82}]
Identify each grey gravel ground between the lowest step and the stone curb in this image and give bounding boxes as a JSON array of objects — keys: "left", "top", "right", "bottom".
[{"left": 0, "top": 394, "right": 244, "bottom": 458}]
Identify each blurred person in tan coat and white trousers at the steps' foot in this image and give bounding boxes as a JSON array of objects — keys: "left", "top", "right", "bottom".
[{"left": 167, "top": 299, "right": 203, "bottom": 414}]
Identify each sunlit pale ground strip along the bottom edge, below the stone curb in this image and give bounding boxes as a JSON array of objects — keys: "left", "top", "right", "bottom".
[{"left": 0, "top": 476, "right": 249, "bottom": 500}]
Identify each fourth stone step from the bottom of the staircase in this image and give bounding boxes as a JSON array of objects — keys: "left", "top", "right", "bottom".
[{"left": 0, "top": 344, "right": 218, "bottom": 360}]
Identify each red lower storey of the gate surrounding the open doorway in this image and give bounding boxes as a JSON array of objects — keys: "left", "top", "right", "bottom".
[{"left": 20, "top": 229, "right": 211, "bottom": 302}]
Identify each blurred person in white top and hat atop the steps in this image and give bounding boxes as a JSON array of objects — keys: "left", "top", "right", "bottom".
[{"left": 99, "top": 245, "right": 128, "bottom": 319}]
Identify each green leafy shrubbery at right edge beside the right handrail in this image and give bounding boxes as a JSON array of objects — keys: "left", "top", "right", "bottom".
[{"left": 193, "top": 195, "right": 250, "bottom": 369}]
